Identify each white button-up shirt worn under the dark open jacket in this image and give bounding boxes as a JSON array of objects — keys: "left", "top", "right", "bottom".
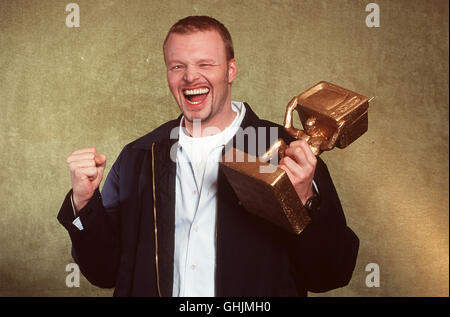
[{"left": 173, "top": 101, "right": 245, "bottom": 297}]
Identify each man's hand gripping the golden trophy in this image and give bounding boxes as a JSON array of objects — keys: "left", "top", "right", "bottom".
[{"left": 278, "top": 140, "right": 317, "bottom": 204}]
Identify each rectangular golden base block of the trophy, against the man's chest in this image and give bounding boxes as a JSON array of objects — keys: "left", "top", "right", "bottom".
[{"left": 220, "top": 147, "right": 311, "bottom": 234}]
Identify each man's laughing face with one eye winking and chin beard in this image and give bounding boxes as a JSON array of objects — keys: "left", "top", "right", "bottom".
[{"left": 164, "top": 30, "right": 236, "bottom": 126}]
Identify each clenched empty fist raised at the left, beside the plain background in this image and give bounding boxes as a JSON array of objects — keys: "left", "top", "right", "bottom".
[{"left": 67, "top": 147, "right": 106, "bottom": 211}]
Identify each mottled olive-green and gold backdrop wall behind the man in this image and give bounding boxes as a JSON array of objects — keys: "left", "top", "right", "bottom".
[{"left": 0, "top": 0, "right": 449, "bottom": 296}]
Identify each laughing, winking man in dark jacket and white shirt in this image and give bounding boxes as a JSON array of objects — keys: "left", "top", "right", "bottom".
[{"left": 58, "top": 16, "right": 359, "bottom": 296}]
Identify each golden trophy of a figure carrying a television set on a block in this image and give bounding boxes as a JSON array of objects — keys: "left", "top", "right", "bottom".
[{"left": 220, "top": 81, "right": 369, "bottom": 234}]
